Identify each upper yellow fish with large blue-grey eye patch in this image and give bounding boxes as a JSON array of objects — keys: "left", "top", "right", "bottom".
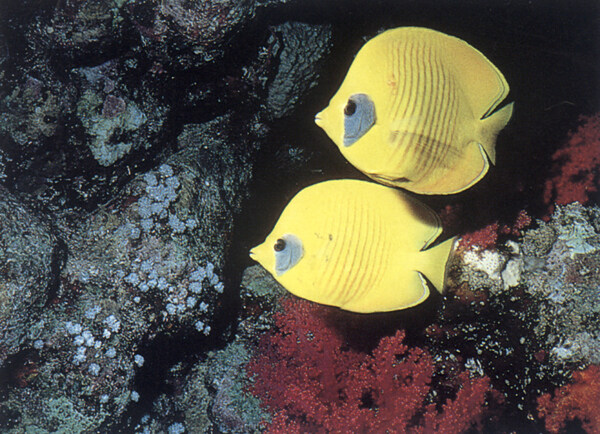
[{"left": 315, "top": 27, "right": 512, "bottom": 194}]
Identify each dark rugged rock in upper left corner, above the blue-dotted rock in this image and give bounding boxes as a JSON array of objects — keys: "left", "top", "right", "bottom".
[{"left": 0, "top": 0, "right": 312, "bottom": 212}]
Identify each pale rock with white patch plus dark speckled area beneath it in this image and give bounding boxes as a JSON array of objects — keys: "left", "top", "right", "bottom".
[{"left": 436, "top": 203, "right": 600, "bottom": 424}]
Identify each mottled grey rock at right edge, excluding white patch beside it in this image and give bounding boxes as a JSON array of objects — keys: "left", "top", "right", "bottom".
[{"left": 522, "top": 203, "right": 600, "bottom": 366}]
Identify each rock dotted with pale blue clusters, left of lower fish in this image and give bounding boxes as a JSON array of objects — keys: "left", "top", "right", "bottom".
[{"left": 0, "top": 113, "right": 259, "bottom": 431}]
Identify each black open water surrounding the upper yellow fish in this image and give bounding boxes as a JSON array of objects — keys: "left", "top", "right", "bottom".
[{"left": 245, "top": 1, "right": 600, "bottom": 238}]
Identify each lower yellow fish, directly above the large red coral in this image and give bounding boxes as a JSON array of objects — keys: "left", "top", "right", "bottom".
[{"left": 250, "top": 180, "right": 453, "bottom": 313}]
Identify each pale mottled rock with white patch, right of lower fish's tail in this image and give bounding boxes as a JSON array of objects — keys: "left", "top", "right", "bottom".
[{"left": 455, "top": 202, "right": 600, "bottom": 366}]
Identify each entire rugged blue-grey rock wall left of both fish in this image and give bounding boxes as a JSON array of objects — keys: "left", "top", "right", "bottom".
[{"left": 0, "top": 0, "right": 338, "bottom": 432}]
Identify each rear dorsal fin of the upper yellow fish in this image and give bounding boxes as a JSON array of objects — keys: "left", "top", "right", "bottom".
[{"left": 443, "top": 31, "right": 509, "bottom": 119}]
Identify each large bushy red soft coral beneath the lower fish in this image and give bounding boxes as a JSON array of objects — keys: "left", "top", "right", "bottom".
[{"left": 247, "top": 299, "right": 489, "bottom": 433}]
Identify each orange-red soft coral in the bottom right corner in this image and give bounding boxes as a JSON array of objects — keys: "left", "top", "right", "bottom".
[{"left": 537, "top": 365, "right": 600, "bottom": 433}]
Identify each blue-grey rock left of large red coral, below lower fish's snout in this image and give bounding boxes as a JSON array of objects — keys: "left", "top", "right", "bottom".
[{"left": 127, "top": 266, "right": 283, "bottom": 433}]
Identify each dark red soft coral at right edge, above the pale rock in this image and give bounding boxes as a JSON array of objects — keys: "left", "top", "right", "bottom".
[{"left": 544, "top": 113, "right": 600, "bottom": 209}]
